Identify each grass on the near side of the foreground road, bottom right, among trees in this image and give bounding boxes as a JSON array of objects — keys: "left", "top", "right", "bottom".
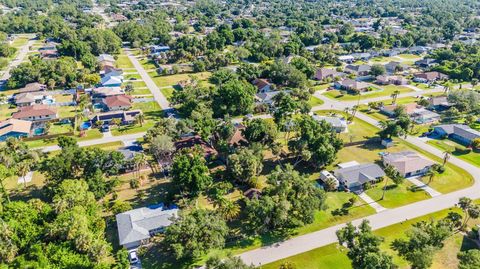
[{"left": 261, "top": 201, "right": 479, "bottom": 269}]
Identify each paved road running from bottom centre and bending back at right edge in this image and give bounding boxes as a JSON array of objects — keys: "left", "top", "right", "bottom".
[{"left": 239, "top": 90, "right": 480, "bottom": 266}]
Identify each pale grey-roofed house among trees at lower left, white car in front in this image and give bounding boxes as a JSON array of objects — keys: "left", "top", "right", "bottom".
[{"left": 116, "top": 205, "right": 179, "bottom": 249}]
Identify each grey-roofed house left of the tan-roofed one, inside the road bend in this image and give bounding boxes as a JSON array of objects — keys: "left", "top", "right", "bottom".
[{"left": 334, "top": 163, "right": 385, "bottom": 191}]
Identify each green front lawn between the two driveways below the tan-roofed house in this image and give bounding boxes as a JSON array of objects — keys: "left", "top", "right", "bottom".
[{"left": 366, "top": 178, "right": 431, "bottom": 208}]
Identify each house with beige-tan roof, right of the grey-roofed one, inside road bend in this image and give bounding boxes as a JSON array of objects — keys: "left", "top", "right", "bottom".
[{"left": 382, "top": 151, "right": 435, "bottom": 177}]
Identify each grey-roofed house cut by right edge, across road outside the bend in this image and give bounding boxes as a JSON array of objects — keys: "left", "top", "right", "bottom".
[{"left": 433, "top": 124, "right": 480, "bottom": 146}]
